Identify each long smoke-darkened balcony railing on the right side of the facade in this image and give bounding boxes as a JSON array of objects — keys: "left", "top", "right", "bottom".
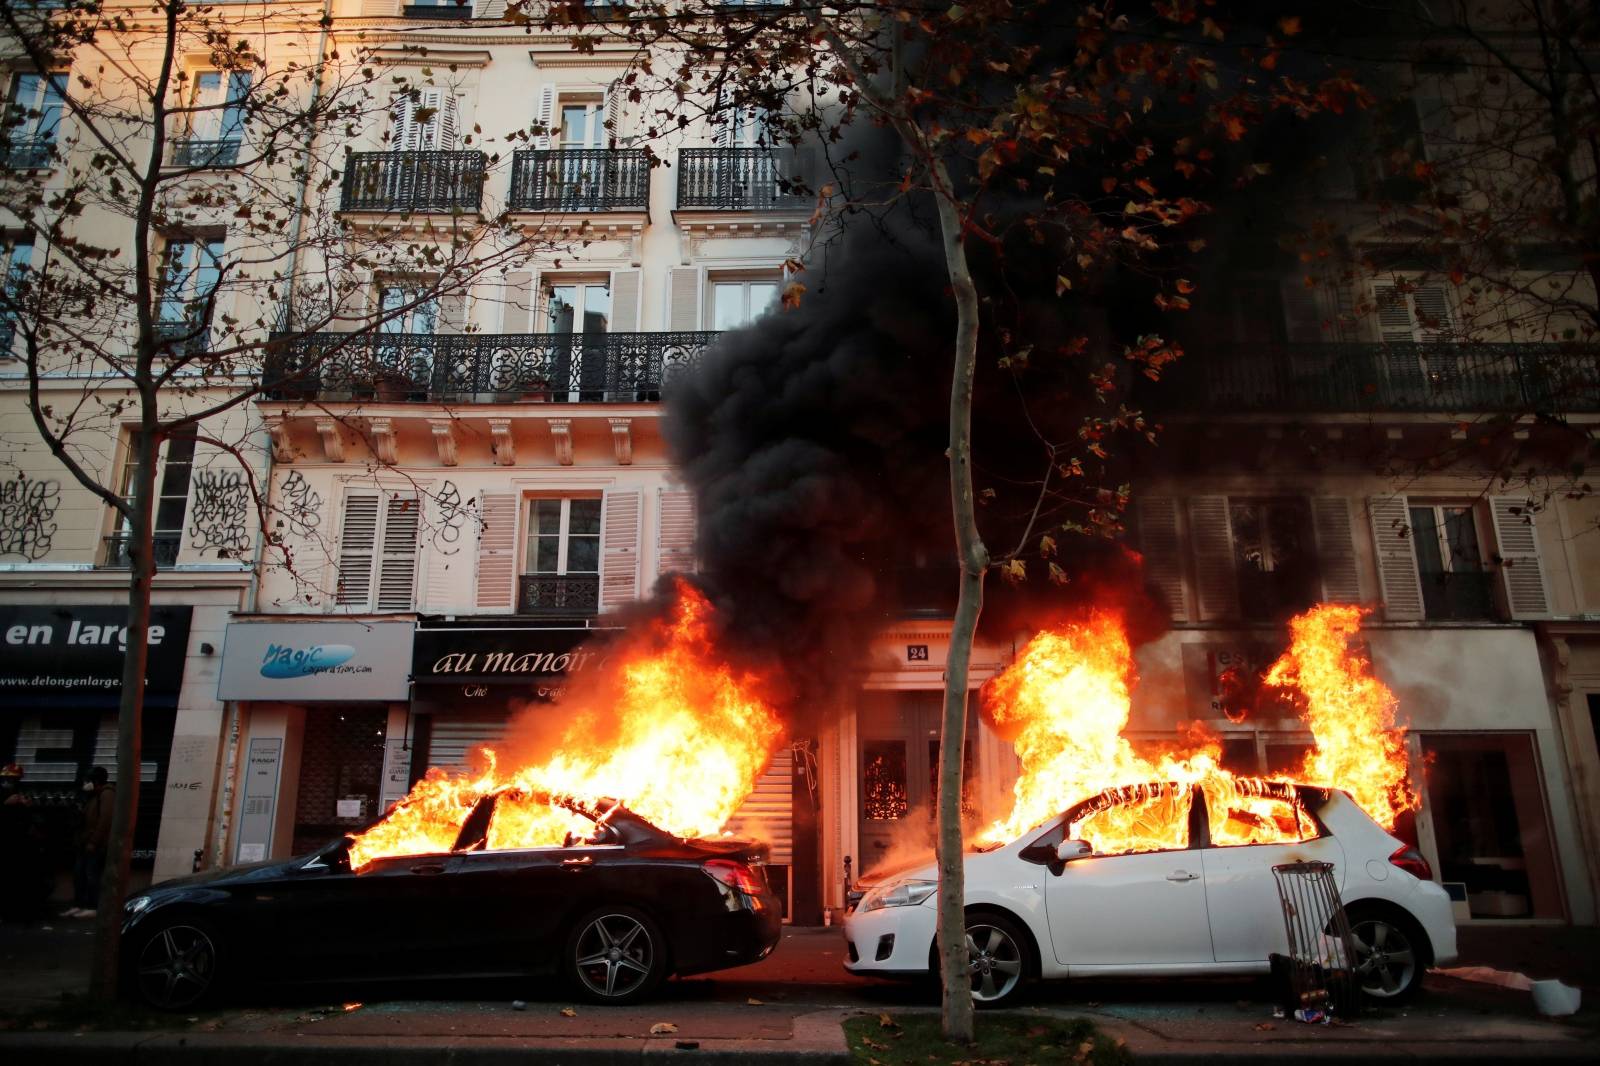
[{"left": 1149, "top": 343, "right": 1600, "bottom": 413}]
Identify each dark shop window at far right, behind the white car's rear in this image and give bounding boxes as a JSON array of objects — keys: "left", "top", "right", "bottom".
[{"left": 1421, "top": 733, "right": 1562, "bottom": 919}]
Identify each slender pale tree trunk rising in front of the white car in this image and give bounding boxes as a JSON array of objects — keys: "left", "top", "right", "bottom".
[{"left": 933, "top": 162, "right": 989, "bottom": 1044}]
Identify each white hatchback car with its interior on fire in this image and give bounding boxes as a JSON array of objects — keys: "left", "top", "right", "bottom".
[{"left": 845, "top": 779, "right": 1456, "bottom": 1007}]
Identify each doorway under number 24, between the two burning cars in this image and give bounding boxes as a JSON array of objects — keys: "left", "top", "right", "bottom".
[{"left": 856, "top": 691, "right": 978, "bottom": 877}]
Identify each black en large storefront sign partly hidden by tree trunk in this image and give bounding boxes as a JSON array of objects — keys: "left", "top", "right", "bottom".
[{"left": 0, "top": 605, "right": 194, "bottom": 707}]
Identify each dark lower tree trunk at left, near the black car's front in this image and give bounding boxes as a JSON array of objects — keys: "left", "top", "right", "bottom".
[{"left": 90, "top": 427, "right": 160, "bottom": 1002}]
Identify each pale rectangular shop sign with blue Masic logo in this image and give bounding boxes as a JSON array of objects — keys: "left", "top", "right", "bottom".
[{"left": 216, "top": 621, "right": 413, "bottom": 703}]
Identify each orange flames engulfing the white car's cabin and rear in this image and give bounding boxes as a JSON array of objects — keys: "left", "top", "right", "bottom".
[{"left": 979, "top": 605, "right": 1418, "bottom": 852}]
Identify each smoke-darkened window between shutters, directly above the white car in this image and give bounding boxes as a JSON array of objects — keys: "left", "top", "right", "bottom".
[{"left": 1227, "top": 498, "right": 1317, "bottom": 618}]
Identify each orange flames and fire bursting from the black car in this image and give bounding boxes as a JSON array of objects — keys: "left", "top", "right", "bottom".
[{"left": 350, "top": 581, "right": 781, "bottom": 869}]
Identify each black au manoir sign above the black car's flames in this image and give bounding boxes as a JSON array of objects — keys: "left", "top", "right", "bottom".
[{"left": 411, "top": 627, "right": 618, "bottom": 681}]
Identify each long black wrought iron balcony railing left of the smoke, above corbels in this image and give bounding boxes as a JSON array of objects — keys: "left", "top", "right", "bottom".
[{"left": 264, "top": 326, "right": 717, "bottom": 403}]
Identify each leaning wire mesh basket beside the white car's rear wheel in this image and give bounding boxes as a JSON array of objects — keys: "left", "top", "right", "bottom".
[{"left": 1270, "top": 863, "right": 1357, "bottom": 1020}]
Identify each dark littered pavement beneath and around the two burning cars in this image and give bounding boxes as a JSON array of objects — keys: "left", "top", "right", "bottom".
[{"left": 0, "top": 927, "right": 1600, "bottom": 1066}]
